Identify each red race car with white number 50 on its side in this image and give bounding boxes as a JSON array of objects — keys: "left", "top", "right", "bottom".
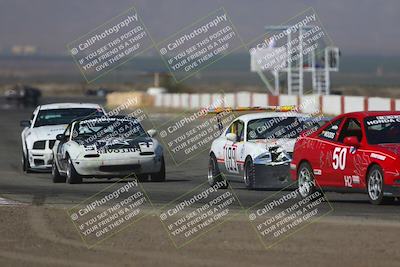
[{"left": 290, "top": 111, "right": 400, "bottom": 204}]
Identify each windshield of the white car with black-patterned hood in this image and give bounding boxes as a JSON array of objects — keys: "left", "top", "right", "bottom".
[{"left": 73, "top": 119, "right": 146, "bottom": 140}]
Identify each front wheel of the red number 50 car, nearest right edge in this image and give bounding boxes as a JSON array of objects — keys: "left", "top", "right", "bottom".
[{"left": 367, "top": 165, "right": 393, "bottom": 205}]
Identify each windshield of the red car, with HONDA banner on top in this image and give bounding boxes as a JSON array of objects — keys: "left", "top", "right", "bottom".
[{"left": 364, "top": 115, "right": 400, "bottom": 145}]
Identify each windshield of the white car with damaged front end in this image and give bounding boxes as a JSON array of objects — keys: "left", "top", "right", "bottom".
[{"left": 247, "top": 117, "right": 321, "bottom": 140}]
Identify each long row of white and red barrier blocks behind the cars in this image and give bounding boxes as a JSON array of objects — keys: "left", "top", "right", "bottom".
[{"left": 154, "top": 92, "right": 400, "bottom": 115}]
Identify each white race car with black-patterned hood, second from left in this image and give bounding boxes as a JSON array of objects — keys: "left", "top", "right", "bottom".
[{"left": 52, "top": 117, "right": 165, "bottom": 183}]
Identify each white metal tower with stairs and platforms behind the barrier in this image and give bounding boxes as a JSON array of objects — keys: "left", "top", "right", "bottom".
[{"left": 250, "top": 25, "right": 339, "bottom": 95}]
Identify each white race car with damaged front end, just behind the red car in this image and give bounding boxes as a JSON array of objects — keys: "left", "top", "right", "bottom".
[{"left": 208, "top": 109, "right": 326, "bottom": 189}]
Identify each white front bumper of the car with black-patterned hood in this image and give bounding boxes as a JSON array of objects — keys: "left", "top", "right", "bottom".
[{"left": 73, "top": 155, "right": 161, "bottom": 177}]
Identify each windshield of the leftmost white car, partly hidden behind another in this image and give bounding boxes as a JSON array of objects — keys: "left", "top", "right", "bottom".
[{"left": 33, "top": 108, "right": 104, "bottom": 127}]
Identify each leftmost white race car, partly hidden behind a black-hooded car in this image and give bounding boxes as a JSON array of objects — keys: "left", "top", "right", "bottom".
[{"left": 20, "top": 103, "right": 105, "bottom": 172}]
